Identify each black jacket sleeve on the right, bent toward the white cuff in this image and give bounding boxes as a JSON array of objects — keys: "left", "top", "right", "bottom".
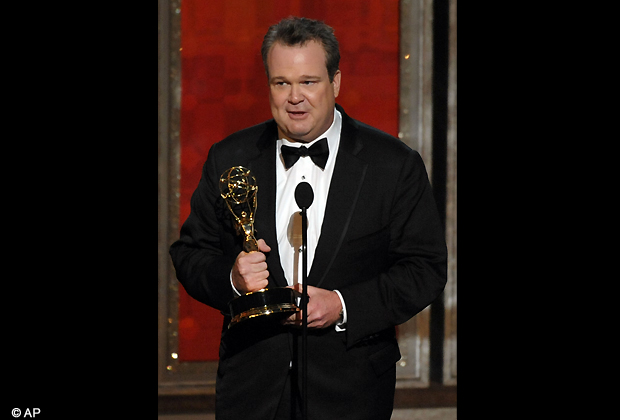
[{"left": 339, "top": 151, "right": 447, "bottom": 346}]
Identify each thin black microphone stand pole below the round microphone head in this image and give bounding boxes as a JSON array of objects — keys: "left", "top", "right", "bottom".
[{"left": 301, "top": 207, "right": 308, "bottom": 420}]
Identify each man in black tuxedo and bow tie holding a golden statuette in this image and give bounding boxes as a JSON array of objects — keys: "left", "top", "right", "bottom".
[{"left": 170, "top": 18, "right": 447, "bottom": 420}]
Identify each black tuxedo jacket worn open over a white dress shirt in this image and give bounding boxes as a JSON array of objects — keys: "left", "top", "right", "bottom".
[{"left": 170, "top": 105, "right": 447, "bottom": 420}]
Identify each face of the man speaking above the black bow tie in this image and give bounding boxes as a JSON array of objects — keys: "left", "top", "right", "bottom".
[{"left": 267, "top": 41, "right": 340, "bottom": 143}]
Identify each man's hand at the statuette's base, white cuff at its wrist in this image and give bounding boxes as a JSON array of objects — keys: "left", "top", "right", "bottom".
[{"left": 283, "top": 284, "right": 342, "bottom": 328}]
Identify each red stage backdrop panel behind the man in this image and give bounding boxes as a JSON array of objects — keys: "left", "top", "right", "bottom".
[{"left": 179, "top": 0, "right": 399, "bottom": 361}]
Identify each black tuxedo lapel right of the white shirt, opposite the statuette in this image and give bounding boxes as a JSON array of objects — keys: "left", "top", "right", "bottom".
[{"left": 308, "top": 108, "right": 368, "bottom": 287}]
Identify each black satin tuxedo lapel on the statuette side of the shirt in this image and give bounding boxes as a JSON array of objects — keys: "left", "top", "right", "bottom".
[{"left": 248, "top": 122, "right": 287, "bottom": 287}]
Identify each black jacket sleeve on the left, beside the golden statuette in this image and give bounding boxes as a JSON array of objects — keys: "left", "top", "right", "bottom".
[{"left": 170, "top": 144, "right": 236, "bottom": 313}]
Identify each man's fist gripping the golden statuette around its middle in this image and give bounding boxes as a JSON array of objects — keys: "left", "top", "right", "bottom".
[{"left": 232, "top": 239, "right": 271, "bottom": 294}]
